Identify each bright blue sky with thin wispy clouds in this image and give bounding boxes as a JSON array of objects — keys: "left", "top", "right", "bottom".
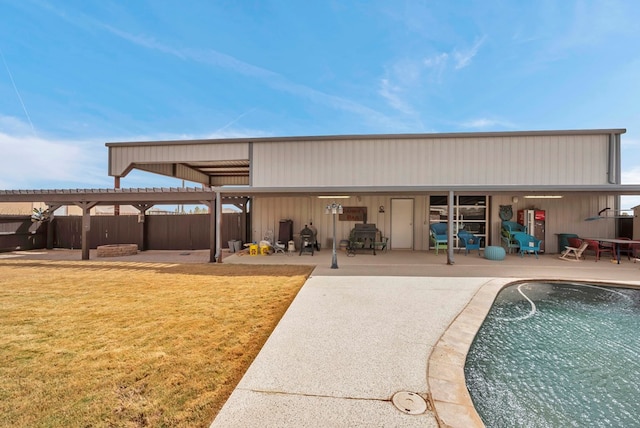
[{"left": 0, "top": 0, "right": 640, "bottom": 208}]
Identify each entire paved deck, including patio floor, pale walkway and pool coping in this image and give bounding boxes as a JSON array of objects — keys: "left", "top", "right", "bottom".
[{"left": 6, "top": 246, "right": 640, "bottom": 428}]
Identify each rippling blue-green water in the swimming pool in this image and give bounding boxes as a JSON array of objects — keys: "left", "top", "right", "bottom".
[{"left": 465, "top": 282, "right": 640, "bottom": 428}]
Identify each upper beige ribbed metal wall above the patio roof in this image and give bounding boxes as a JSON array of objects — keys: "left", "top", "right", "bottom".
[{"left": 253, "top": 135, "right": 608, "bottom": 187}]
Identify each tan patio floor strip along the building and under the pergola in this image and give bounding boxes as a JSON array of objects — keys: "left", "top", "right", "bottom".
[{"left": 5, "top": 248, "right": 640, "bottom": 281}]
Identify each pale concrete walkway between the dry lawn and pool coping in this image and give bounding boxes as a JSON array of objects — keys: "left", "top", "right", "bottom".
[{"left": 212, "top": 275, "right": 487, "bottom": 427}]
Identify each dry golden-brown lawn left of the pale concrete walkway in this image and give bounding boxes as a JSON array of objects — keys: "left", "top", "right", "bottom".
[{"left": 0, "top": 260, "right": 312, "bottom": 427}]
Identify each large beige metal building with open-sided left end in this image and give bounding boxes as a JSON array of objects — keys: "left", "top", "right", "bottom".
[{"left": 106, "top": 129, "right": 640, "bottom": 258}]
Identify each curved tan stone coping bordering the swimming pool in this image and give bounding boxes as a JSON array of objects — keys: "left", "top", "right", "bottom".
[{"left": 427, "top": 278, "right": 640, "bottom": 428}]
